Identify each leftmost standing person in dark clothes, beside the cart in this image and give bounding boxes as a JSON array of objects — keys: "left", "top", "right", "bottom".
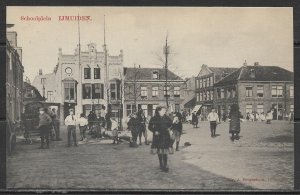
[{"left": 38, "top": 108, "right": 52, "bottom": 149}]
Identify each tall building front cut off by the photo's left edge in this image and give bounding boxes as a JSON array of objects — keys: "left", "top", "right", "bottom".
[{"left": 6, "top": 32, "right": 24, "bottom": 121}]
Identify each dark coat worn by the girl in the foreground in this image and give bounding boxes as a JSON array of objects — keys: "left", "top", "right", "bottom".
[{"left": 148, "top": 115, "right": 172, "bottom": 149}]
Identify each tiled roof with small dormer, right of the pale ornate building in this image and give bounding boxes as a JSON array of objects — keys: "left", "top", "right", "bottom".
[{"left": 124, "top": 67, "right": 184, "bottom": 81}]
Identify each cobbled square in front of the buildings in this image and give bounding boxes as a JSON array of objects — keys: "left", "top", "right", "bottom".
[{"left": 7, "top": 121, "right": 293, "bottom": 189}]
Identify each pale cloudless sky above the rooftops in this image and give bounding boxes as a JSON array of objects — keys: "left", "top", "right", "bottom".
[{"left": 6, "top": 7, "right": 293, "bottom": 81}]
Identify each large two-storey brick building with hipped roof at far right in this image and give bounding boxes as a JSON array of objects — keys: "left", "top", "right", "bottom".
[{"left": 214, "top": 63, "right": 294, "bottom": 120}]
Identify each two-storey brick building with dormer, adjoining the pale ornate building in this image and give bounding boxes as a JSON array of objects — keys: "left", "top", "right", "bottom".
[{"left": 124, "top": 67, "right": 185, "bottom": 116}]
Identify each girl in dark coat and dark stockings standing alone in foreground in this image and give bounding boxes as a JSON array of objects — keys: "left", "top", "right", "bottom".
[{"left": 148, "top": 106, "right": 172, "bottom": 172}]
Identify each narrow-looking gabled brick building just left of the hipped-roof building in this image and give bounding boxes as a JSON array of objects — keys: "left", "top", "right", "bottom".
[{"left": 194, "top": 64, "right": 237, "bottom": 118}]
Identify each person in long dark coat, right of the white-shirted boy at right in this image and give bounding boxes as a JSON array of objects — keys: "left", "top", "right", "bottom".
[{"left": 229, "top": 104, "right": 241, "bottom": 140}]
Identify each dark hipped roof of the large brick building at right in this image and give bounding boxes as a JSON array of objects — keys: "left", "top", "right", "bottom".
[{"left": 215, "top": 65, "right": 294, "bottom": 86}]
